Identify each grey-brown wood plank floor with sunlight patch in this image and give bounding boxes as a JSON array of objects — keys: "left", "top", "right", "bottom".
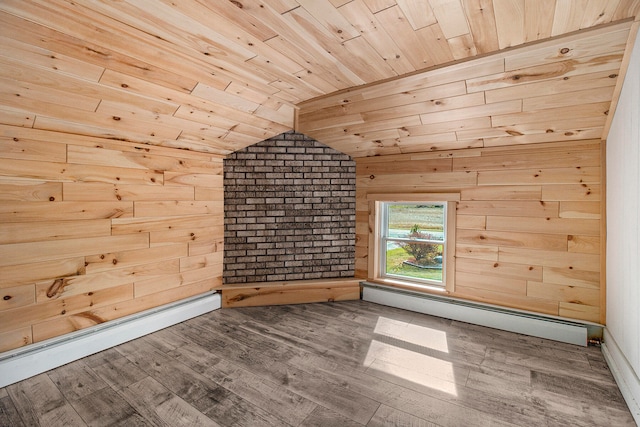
[{"left": 0, "top": 301, "right": 635, "bottom": 427}]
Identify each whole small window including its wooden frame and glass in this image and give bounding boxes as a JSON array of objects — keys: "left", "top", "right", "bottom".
[{"left": 369, "top": 193, "right": 459, "bottom": 291}]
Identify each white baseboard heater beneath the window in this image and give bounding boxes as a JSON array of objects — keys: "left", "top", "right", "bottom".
[{"left": 361, "top": 282, "right": 603, "bottom": 346}]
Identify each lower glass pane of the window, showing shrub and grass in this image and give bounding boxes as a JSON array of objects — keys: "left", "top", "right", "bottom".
[{"left": 385, "top": 241, "right": 444, "bottom": 282}]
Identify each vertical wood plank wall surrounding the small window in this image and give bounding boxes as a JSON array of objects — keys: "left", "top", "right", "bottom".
[{"left": 356, "top": 140, "right": 604, "bottom": 322}]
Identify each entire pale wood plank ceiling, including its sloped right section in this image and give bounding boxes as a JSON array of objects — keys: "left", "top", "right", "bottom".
[{"left": 0, "top": 0, "right": 640, "bottom": 157}]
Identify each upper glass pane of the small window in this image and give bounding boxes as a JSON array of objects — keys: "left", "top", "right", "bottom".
[{"left": 387, "top": 203, "right": 445, "bottom": 242}]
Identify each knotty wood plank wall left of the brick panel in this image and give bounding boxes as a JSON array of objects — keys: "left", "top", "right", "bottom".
[{"left": 0, "top": 125, "right": 224, "bottom": 351}]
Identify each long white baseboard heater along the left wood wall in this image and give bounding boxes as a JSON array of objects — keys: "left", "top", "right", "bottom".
[{"left": 0, "top": 292, "right": 222, "bottom": 388}]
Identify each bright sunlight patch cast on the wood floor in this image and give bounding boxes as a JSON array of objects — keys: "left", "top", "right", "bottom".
[{"left": 363, "top": 317, "right": 458, "bottom": 396}]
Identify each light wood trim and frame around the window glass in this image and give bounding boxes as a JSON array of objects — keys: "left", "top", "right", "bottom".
[{"left": 367, "top": 193, "right": 460, "bottom": 293}]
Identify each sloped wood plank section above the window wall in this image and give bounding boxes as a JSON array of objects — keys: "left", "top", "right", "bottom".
[{"left": 296, "top": 22, "right": 631, "bottom": 157}]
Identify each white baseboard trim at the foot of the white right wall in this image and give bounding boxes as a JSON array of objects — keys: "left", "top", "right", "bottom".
[{"left": 602, "top": 328, "right": 640, "bottom": 426}]
